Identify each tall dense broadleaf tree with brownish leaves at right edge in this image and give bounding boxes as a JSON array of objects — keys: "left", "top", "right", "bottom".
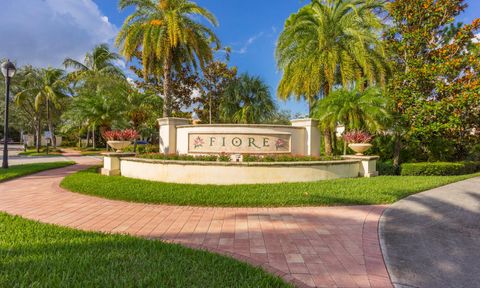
[{"left": 385, "top": 0, "right": 480, "bottom": 166}]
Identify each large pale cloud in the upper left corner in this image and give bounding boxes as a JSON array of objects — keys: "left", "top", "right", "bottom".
[{"left": 0, "top": 0, "right": 118, "bottom": 67}]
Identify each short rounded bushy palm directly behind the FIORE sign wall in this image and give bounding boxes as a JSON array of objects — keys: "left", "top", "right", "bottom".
[{"left": 220, "top": 74, "right": 276, "bottom": 124}]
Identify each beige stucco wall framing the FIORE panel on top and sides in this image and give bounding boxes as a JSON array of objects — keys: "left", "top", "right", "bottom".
[{"left": 176, "top": 124, "right": 309, "bottom": 155}]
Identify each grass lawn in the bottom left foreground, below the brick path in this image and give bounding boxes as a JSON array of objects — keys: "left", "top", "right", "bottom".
[{"left": 0, "top": 213, "right": 291, "bottom": 287}]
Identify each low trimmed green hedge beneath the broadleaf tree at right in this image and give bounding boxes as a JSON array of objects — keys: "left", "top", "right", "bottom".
[{"left": 401, "top": 162, "right": 480, "bottom": 176}]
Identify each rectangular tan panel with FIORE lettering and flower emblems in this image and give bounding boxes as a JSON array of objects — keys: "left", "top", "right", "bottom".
[{"left": 188, "top": 133, "right": 291, "bottom": 154}]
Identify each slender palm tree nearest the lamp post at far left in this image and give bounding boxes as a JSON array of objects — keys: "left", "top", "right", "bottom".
[{"left": 16, "top": 68, "right": 68, "bottom": 148}]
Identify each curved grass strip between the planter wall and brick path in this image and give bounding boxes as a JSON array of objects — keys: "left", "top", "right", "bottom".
[{"left": 61, "top": 169, "right": 480, "bottom": 207}]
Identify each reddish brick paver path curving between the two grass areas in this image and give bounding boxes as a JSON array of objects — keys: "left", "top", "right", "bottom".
[{"left": 0, "top": 157, "right": 391, "bottom": 288}]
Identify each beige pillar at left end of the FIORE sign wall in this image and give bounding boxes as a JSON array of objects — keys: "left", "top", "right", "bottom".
[{"left": 158, "top": 117, "right": 190, "bottom": 154}]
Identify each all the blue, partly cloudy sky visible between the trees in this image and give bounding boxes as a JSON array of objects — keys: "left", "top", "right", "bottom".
[{"left": 0, "top": 0, "right": 480, "bottom": 114}]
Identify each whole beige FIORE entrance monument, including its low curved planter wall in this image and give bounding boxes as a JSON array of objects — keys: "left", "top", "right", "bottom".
[{"left": 102, "top": 118, "right": 378, "bottom": 185}]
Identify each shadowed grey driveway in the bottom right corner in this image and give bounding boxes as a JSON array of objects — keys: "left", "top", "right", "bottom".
[{"left": 380, "top": 178, "right": 480, "bottom": 288}]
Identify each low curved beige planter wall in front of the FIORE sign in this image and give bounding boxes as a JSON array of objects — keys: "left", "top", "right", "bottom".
[{"left": 120, "top": 158, "right": 361, "bottom": 185}]
